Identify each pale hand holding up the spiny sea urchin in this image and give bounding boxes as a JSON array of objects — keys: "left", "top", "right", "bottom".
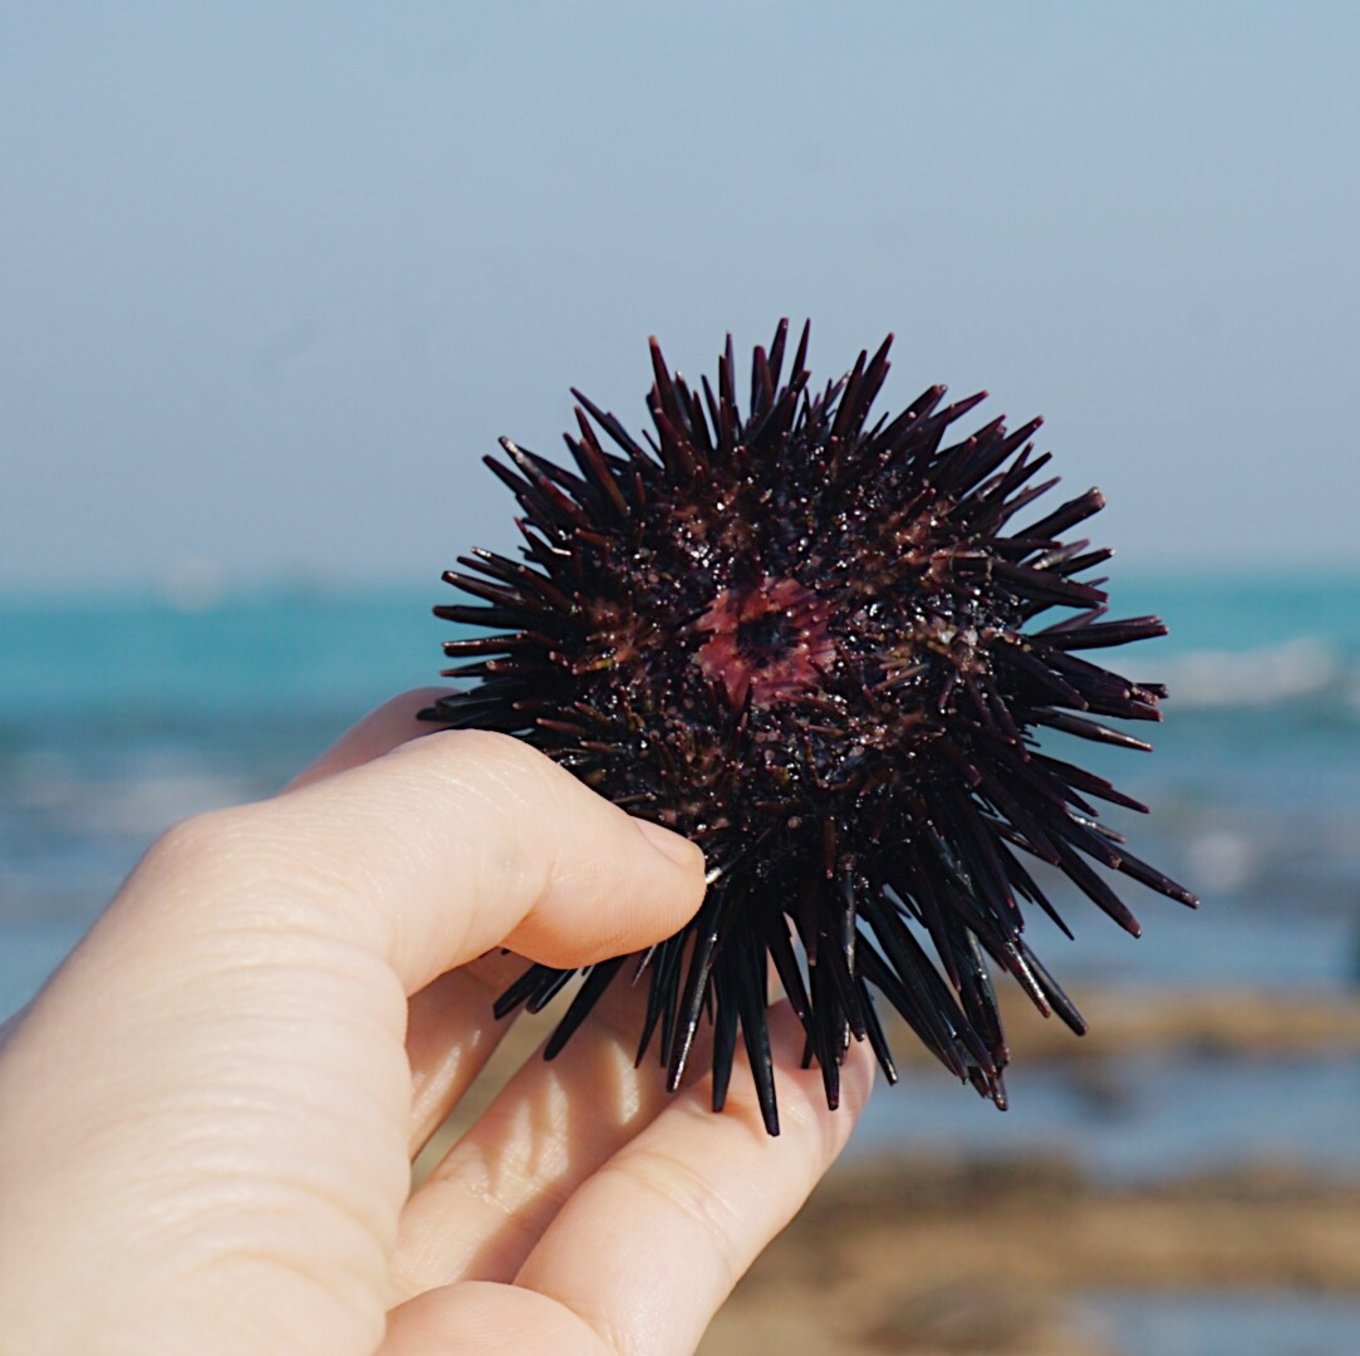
[{"left": 0, "top": 692, "right": 872, "bottom": 1356}]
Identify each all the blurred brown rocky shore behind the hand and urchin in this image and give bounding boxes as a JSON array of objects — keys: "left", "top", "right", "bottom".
[{"left": 416, "top": 987, "right": 1360, "bottom": 1356}]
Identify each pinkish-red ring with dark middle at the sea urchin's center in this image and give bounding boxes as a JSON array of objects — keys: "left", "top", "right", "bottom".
[{"left": 695, "top": 579, "right": 836, "bottom": 710}]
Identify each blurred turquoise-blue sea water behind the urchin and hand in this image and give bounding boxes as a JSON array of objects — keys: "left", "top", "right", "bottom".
[{"left": 0, "top": 575, "right": 1360, "bottom": 1158}]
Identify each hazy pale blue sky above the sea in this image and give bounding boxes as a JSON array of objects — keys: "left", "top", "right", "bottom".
[{"left": 0, "top": 0, "right": 1360, "bottom": 589}]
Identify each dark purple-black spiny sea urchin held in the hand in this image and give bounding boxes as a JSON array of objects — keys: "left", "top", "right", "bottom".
[{"left": 424, "top": 322, "right": 1195, "bottom": 1134}]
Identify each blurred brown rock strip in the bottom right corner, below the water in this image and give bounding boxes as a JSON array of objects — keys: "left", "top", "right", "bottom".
[{"left": 700, "top": 1156, "right": 1360, "bottom": 1356}]
